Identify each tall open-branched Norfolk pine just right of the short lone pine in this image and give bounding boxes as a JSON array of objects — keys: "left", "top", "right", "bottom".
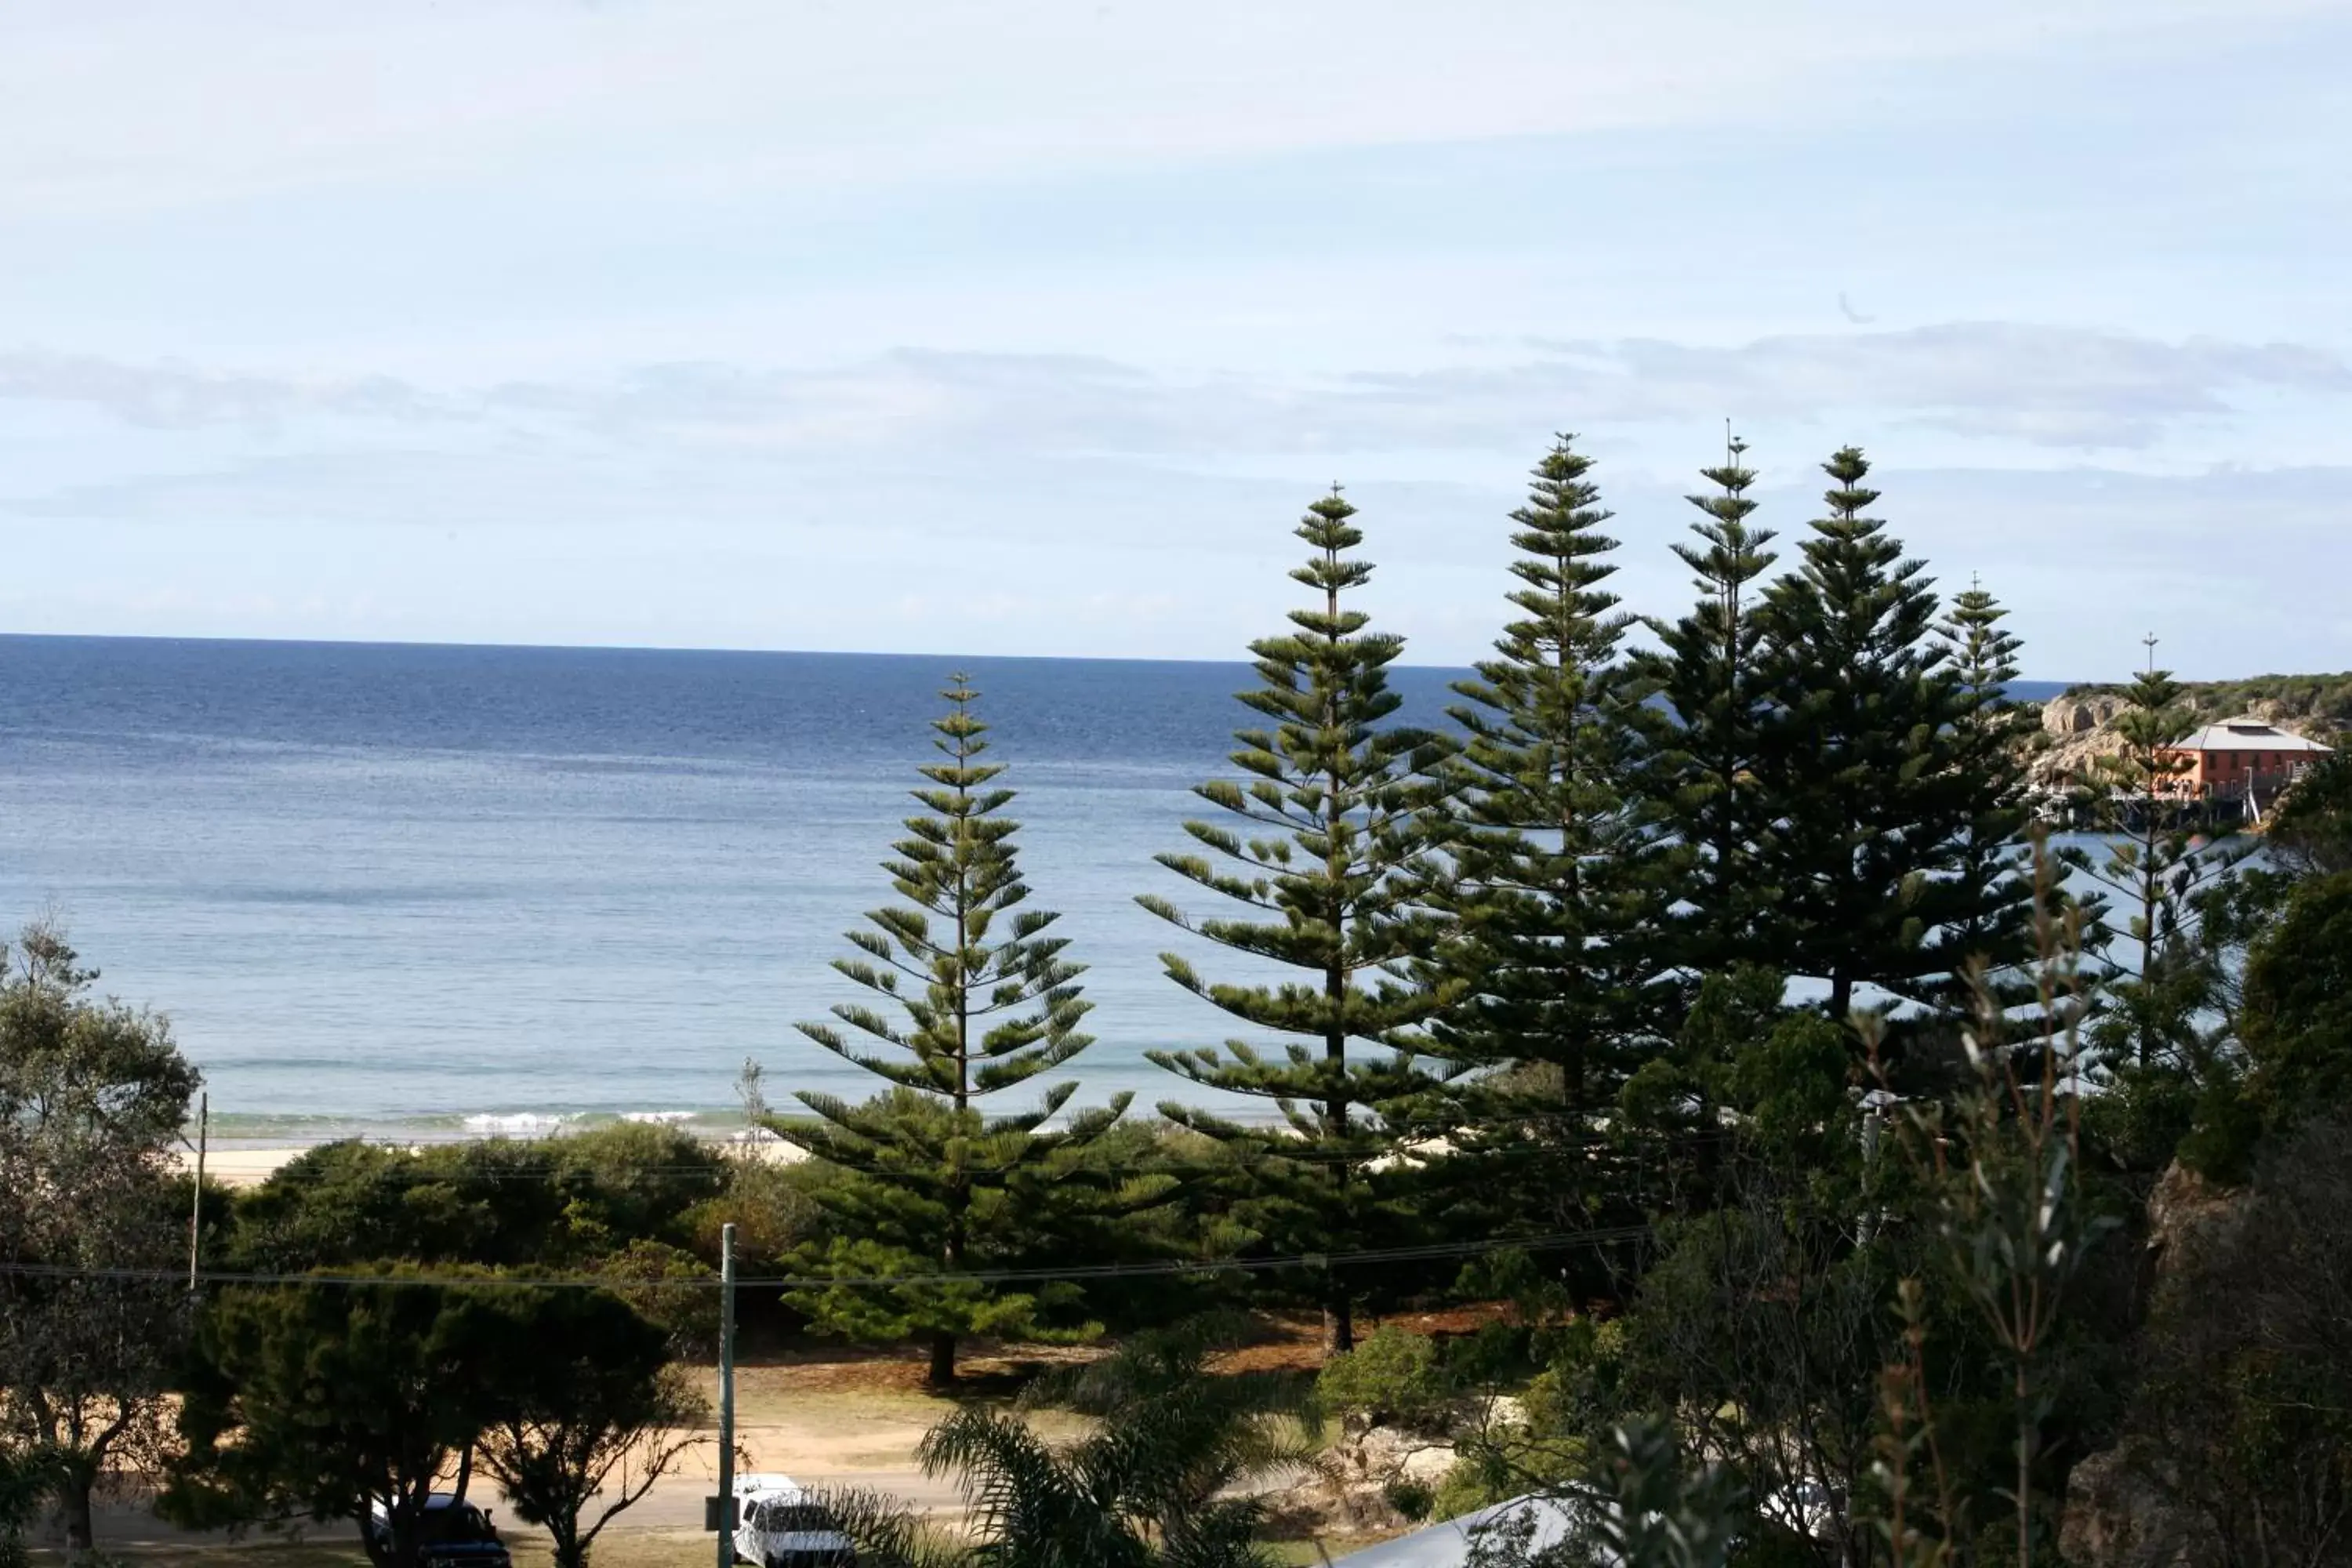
[{"left": 1138, "top": 487, "right": 1444, "bottom": 1352}]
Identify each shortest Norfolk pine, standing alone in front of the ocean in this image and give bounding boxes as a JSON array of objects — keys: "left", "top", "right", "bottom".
[{"left": 767, "top": 675, "right": 1134, "bottom": 1385}]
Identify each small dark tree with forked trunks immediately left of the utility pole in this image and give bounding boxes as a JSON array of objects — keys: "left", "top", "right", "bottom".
[{"left": 477, "top": 1290, "right": 708, "bottom": 1568}]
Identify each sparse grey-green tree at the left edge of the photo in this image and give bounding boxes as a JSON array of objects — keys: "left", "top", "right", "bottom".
[{"left": 0, "top": 926, "right": 198, "bottom": 1559}]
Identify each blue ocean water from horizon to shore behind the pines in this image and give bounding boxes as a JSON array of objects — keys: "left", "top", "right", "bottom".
[{"left": 0, "top": 637, "right": 2058, "bottom": 1138}]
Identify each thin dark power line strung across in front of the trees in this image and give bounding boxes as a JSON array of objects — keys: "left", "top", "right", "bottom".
[{"left": 0, "top": 1225, "right": 1649, "bottom": 1290}]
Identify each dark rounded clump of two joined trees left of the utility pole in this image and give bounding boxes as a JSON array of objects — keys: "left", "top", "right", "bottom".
[{"left": 160, "top": 1265, "right": 701, "bottom": 1568}]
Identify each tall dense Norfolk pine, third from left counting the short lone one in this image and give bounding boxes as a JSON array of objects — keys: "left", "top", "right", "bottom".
[{"left": 1428, "top": 435, "right": 1677, "bottom": 1227}]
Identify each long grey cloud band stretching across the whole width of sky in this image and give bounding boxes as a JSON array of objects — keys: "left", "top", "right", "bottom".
[{"left": 0, "top": 322, "right": 2352, "bottom": 463}]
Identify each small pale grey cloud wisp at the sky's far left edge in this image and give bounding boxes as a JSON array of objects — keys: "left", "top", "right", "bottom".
[{"left": 0, "top": 348, "right": 447, "bottom": 430}]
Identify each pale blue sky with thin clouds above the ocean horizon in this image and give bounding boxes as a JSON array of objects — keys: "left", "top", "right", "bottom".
[{"left": 0, "top": 0, "right": 2352, "bottom": 680}]
